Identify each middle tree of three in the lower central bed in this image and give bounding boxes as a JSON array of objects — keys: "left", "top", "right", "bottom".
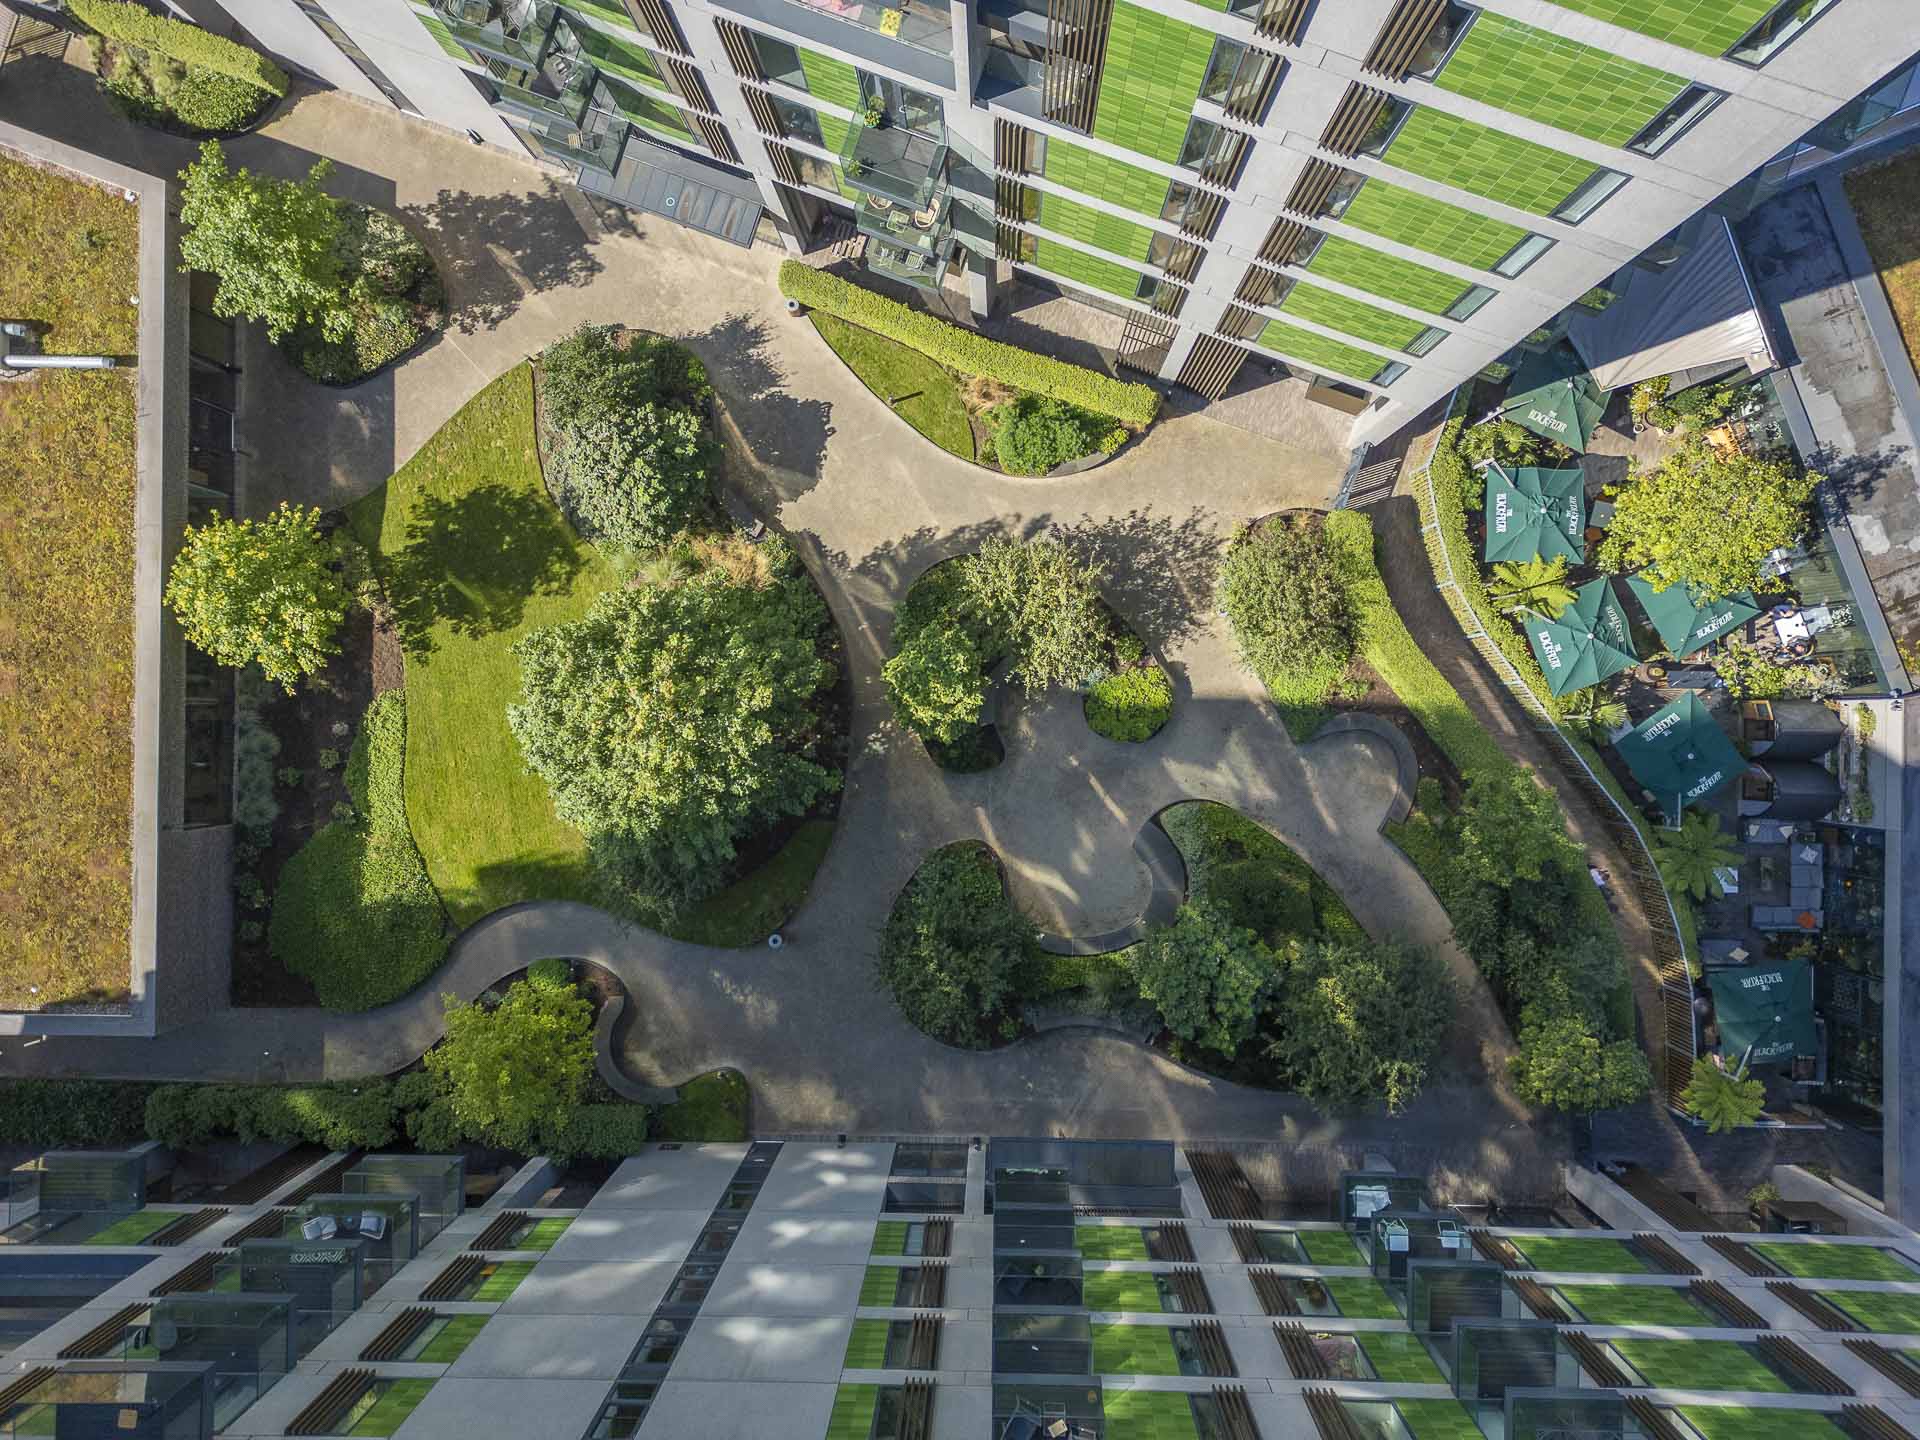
[{"left": 1131, "top": 902, "right": 1277, "bottom": 1056}]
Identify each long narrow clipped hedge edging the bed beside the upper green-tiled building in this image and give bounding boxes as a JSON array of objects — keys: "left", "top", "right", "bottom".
[{"left": 780, "top": 259, "right": 1160, "bottom": 430}]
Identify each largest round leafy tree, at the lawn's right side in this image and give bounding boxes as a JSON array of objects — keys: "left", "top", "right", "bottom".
[{"left": 507, "top": 541, "right": 839, "bottom": 910}]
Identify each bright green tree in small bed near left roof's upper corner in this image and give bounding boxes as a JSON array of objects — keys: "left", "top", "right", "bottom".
[{"left": 180, "top": 140, "right": 353, "bottom": 340}]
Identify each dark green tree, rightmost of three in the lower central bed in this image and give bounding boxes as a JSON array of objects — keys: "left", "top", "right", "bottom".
[{"left": 1267, "top": 939, "right": 1455, "bottom": 1112}]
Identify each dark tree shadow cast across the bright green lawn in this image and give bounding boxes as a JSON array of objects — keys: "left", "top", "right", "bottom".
[{"left": 384, "top": 482, "right": 584, "bottom": 655}]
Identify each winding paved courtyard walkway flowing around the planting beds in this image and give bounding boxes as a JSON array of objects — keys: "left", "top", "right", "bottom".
[{"left": 0, "top": 73, "right": 1563, "bottom": 1185}]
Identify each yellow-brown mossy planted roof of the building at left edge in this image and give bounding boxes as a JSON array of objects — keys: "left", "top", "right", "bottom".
[{"left": 0, "top": 157, "right": 140, "bottom": 1010}]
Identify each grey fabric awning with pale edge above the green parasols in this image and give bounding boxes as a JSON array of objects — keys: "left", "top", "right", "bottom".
[{"left": 1567, "top": 215, "right": 1778, "bottom": 390}]
